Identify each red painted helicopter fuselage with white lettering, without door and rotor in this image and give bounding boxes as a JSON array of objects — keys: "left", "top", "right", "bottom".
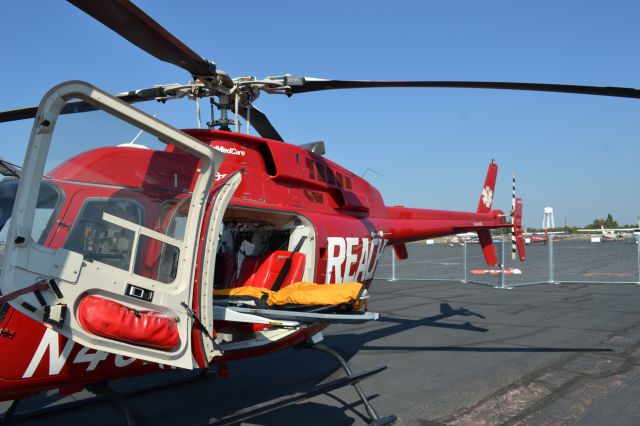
[{"left": 0, "top": 130, "right": 511, "bottom": 400}]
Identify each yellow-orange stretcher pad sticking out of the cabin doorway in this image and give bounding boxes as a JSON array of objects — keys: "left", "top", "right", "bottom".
[{"left": 213, "top": 282, "right": 364, "bottom": 306}]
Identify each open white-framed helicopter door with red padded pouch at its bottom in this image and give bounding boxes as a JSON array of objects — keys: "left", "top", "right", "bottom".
[{"left": 0, "top": 81, "right": 225, "bottom": 368}]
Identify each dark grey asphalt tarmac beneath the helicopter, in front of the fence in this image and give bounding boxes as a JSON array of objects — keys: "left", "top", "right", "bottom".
[{"left": 5, "top": 280, "right": 640, "bottom": 426}]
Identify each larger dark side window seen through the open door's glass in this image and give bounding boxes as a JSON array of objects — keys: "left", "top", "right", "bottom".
[{"left": 64, "top": 198, "right": 144, "bottom": 270}]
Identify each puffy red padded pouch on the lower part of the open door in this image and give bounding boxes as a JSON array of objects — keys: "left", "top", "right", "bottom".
[{"left": 77, "top": 296, "right": 180, "bottom": 351}]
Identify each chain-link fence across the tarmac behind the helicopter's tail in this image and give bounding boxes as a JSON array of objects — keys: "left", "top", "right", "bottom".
[{"left": 376, "top": 235, "right": 640, "bottom": 287}]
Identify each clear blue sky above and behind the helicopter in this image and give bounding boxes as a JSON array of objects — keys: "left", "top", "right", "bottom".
[{"left": 0, "top": 0, "right": 640, "bottom": 227}]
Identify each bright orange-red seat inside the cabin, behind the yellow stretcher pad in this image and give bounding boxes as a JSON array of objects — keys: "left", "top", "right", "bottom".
[{"left": 243, "top": 250, "right": 305, "bottom": 289}]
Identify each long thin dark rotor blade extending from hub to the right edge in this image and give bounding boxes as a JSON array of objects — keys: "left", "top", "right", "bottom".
[{"left": 284, "top": 76, "right": 640, "bottom": 99}]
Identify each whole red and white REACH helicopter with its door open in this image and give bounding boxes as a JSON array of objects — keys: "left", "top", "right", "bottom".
[{"left": 0, "top": 0, "right": 640, "bottom": 424}]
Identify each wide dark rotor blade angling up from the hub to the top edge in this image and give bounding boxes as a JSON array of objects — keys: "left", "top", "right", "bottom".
[{"left": 68, "top": 0, "right": 216, "bottom": 76}]
